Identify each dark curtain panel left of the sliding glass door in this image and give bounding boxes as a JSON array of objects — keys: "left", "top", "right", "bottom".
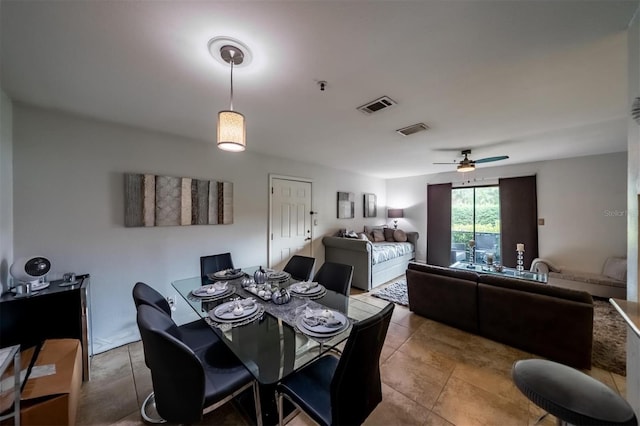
[{"left": 427, "top": 183, "right": 451, "bottom": 266}]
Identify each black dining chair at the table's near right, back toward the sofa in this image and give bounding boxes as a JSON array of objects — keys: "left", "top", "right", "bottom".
[{"left": 276, "top": 303, "right": 394, "bottom": 426}]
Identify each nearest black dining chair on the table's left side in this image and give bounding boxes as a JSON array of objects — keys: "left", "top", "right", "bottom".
[{"left": 137, "top": 304, "right": 262, "bottom": 425}]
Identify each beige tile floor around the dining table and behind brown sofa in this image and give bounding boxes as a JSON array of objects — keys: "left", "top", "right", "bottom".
[{"left": 77, "top": 282, "right": 626, "bottom": 426}]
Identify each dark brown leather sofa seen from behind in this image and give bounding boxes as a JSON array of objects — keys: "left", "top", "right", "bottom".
[{"left": 407, "top": 262, "right": 593, "bottom": 369}]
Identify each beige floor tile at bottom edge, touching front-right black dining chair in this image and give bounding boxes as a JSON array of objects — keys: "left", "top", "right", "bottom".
[{"left": 364, "top": 384, "right": 430, "bottom": 426}]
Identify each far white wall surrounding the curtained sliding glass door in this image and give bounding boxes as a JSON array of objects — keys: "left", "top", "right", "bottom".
[{"left": 387, "top": 153, "right": 627, "bottom": 272}]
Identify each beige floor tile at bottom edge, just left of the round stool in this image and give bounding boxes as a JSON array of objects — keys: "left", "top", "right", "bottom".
[{"left": 433, "top": 377, "right": 528, "bottom": 426}]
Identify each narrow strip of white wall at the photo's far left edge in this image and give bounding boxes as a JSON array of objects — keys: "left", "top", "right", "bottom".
[{"left": 0, "top": 91, "right": 13, "bottom": 291}]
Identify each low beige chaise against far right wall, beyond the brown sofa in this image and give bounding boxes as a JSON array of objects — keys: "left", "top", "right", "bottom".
[{"left": 530, "top": 257, "right": 627, "bottom": 300}]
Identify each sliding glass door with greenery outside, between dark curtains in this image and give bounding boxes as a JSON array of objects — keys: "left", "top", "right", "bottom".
[{"left": 451, "top": 186, "right": 500, "bottom": 263}]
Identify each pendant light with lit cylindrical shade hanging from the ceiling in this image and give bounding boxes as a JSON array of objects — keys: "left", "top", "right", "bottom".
[{"left": 218, "top": 45, "right": 247, "bottom": 152}]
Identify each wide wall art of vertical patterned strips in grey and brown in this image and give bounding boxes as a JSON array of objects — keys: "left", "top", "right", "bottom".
[{"left": 124, "top": 173, "right": 233, "bottom": 227}]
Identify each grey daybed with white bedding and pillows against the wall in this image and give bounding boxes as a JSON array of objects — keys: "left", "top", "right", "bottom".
[{"left": 322, "top": 227, "right": 418, "bottom": 291}]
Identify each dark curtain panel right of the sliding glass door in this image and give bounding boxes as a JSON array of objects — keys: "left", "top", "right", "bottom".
[{"left": 499, "top": 176, "right": 538, "bottom": 270}]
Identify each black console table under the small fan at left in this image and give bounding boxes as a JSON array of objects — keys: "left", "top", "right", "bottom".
[{"left": 0, "top": 274, "right": 93, "bottom": 381}]
